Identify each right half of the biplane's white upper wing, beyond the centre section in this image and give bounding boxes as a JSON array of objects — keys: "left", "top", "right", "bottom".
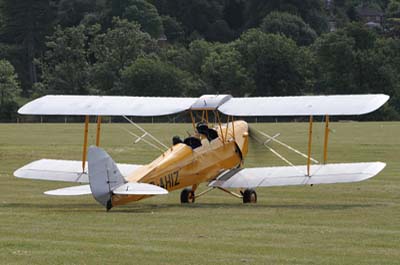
[{"left": 218, "top": 94, "right": 389, "bottom": 116}]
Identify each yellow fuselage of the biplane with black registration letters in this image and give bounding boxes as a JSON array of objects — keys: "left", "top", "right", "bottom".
[{"left": 112, "top": 121, "right": 248, "bottom": 206}]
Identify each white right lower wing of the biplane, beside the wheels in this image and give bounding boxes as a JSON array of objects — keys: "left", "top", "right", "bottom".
[{"left": 209, "top": 162, "right": 386, "bottom": 188}]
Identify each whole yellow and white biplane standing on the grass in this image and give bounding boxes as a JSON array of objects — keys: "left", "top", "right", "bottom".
[{"left": 14, "top": 94, "right": 389, "bottom": 210}]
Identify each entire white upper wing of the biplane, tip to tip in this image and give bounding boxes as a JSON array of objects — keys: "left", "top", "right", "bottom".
[{"left": 18, "top": 94, "right": 389, "bottom": 116}]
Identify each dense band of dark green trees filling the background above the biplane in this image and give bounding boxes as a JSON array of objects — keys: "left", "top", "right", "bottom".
[{"left": 0, "top": 0, "right": 400, "bottom": 120}]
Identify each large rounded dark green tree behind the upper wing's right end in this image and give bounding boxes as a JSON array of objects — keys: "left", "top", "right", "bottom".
[{"left": 313, "top": 23, "right": 386, "bottom": 94}]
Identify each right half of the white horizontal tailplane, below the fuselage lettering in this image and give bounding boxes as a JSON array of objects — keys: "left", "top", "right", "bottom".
[{"left": 113, "top": 182, "right": 168, "bottom": 195}]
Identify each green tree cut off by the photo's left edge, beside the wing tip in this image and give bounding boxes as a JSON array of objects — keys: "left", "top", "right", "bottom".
[{"left": 0, "top": 60, "right": 20, "bottom": 121}]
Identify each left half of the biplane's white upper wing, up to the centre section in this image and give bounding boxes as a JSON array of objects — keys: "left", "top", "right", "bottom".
[{"left": 18, "top": 95, "right": 197, "bottom": 116}]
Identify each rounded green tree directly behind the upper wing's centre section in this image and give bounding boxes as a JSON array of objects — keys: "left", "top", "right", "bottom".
[{"left": 201, "top": 45, "right": 254, "bottom": 96}]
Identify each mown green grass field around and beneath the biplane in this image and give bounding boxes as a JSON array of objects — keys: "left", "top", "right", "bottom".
[{"left": 0, "top": 122, "right": 400, "bottom": 264}]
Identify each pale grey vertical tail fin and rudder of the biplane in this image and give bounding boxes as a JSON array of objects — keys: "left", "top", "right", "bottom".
[{"left": 88, "top": 146, "right": 126, "bottom": 210}]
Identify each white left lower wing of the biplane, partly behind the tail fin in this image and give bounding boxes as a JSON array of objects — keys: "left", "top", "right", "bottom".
[{"left": 14, "top": 159, "right": 140, "bottom": 183}]
